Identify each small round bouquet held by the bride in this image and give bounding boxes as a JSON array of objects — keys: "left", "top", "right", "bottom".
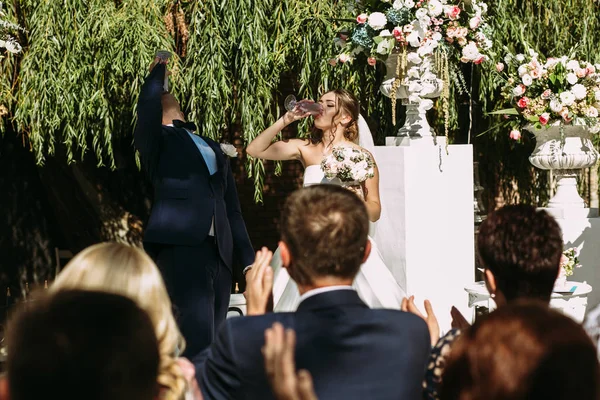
[{"left": 321, "top": 146, "right": 375, "bottom": 183}]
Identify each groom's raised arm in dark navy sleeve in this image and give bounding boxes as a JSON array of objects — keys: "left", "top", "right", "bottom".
[{"left": 133, "top": 61, "right": 166, "bottom": 176}]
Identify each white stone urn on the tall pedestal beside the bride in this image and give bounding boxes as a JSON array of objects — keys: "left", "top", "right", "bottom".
[{"left": 379, "top": 52, "right": 444, "bottom": 139}]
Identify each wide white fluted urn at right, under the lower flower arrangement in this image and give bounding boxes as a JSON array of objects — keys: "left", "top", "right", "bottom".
[{"left": 525, "top": 124, "right": 598, "bottom": 209}]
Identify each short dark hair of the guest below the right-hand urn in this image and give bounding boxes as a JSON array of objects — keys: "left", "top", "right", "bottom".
[{"left": 477, "top": 204, "right": 563, "bottom": 301}]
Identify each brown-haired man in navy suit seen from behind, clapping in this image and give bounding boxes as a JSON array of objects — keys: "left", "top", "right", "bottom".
[{"left": 198, "top": 185, "right": 431, "bottom": 400}]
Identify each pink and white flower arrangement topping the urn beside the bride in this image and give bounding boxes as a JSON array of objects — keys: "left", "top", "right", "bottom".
[{"left": 337, "top": 0, "right": 492, "bottom": 65}]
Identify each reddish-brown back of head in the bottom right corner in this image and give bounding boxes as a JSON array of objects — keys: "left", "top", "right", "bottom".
[{"left": 440, "top": 300, "right": 600, "bottom": 400}]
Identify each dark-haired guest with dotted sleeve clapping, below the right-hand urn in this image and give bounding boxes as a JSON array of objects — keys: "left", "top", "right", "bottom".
[{"left": 402, "top": 204, "right": 563, "bottom": 400}]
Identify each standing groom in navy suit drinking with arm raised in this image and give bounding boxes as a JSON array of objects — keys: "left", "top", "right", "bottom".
[{"left": 134, "top": 58, "right": 254, "bottom": 359}]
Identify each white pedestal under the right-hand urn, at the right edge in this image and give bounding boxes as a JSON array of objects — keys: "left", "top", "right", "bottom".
[{"left": 545, "top": 208, "right": 600, "bottom": 312}]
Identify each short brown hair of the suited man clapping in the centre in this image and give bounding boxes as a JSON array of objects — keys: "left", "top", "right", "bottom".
[{"left": 281, "top": 185, "right": 369, "bottom": 285}]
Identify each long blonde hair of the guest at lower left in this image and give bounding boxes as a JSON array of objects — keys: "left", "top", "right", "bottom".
[{"left": 50, "top": 243, "right": 186, "bottom": 400}]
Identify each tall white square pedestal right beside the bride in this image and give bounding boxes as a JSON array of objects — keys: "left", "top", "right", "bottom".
[{"left": 375, "top": 137, "right": 475, "bottom": 331}]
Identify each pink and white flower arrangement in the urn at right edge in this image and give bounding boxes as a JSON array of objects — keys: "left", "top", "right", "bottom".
[{"left": 494, "top": 50, "right": 600, "bottom": 136}]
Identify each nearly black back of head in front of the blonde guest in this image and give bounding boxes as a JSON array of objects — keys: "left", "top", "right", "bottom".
[{"left": 7, "top": 291, "right": 159, "bottom": 400}]
